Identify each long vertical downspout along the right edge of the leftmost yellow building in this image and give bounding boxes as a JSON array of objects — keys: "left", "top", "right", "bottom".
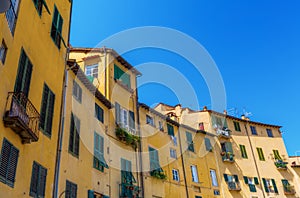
[{"left": 53, "top": 1, "right": 73, "bottom": 198}]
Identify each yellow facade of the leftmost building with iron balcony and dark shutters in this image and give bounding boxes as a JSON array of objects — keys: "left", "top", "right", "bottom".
[{"left": 0, "top": 0, "right": 72, "bottom": 197}]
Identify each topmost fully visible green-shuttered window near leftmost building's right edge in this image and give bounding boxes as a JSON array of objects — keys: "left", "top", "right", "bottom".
[{"left": 51, "top": 5, "right": 63, "bottom": 49}]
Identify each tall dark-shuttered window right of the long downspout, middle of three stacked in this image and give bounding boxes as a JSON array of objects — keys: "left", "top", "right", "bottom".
[{"left": 69, "top": 113, "right": 80, "bottom": 157}]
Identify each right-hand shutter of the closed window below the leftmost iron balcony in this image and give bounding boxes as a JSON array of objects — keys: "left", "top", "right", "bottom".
[{"left": 7, "top": 146, "right": 19, "bottom": 186}]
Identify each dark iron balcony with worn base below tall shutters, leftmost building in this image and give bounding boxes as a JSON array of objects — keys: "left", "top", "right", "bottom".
[{"left": 3, "top": 92, "right": 40, "bottom": 144}]
